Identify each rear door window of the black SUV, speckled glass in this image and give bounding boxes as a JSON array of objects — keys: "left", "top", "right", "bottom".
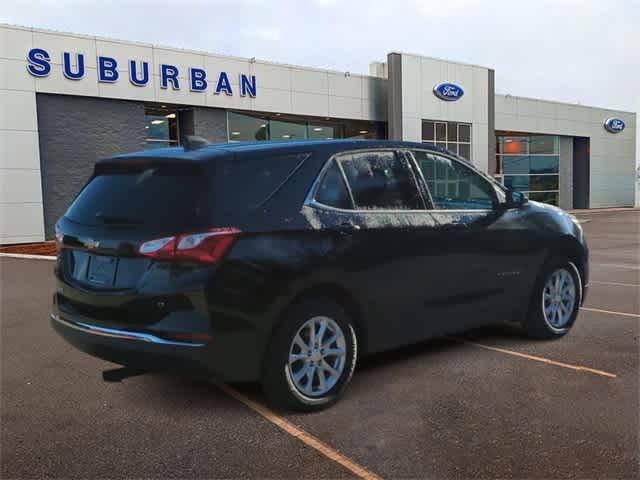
[{"left": 339, "top": 151, "right": 424, "bottom": 210}]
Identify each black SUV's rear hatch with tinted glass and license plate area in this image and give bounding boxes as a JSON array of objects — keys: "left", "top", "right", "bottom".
[{"left": 56, "top": 159, "right": 209, "bottom": 320}]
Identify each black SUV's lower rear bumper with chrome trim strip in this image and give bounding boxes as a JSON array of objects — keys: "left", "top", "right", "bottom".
[{"left": 50, "top": 305, "right": 261, "bottom": 381}]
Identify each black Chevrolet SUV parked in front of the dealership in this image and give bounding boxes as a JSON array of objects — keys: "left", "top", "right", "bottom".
[{"left": 51, "top": 140, "right": 588, "bottom": 410}]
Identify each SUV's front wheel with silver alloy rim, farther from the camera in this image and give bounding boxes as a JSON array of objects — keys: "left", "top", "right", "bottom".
[{"left": 525, "top": 258, "right": 583, "bottom": 339}]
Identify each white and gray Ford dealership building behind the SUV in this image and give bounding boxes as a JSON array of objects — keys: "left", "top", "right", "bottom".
[{"left": 0, "top": 25, "right": 637, "bottom": 244}]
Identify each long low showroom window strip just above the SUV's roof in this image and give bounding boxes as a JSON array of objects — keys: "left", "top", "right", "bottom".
[{"left": 227, "top": 112, "right": 386, "bottom": 142}]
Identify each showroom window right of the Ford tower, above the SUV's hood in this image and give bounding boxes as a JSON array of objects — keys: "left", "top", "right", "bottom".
[{"left": 496, "top": 135, "right": 560, "bottom": 205}]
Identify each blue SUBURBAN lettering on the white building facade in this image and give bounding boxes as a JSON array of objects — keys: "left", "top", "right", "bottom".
[{"left": 27, "top": 48, "right": 256, "bottom": 97}]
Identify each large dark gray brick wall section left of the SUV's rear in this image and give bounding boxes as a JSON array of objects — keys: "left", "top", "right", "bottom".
[{"left": 36, "top": 94, "right": 144, "bottom": 239}]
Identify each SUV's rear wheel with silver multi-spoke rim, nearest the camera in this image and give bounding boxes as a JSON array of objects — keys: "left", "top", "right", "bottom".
[{"left": 262, "top": 298, "right": 358, "bottom": 412}]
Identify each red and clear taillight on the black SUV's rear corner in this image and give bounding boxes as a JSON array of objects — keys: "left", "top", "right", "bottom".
[{"left": 138, "top": 227, "right": 240, "bottom": 262}]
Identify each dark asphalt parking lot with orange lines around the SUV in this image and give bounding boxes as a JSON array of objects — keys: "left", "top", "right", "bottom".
[{"left": 0, "top": 210, "right": 640, "bottom": 478}]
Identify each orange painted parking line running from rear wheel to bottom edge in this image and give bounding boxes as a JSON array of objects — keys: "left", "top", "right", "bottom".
[{"left": 218, "top": 384, "right": 382, "bottom": 480}]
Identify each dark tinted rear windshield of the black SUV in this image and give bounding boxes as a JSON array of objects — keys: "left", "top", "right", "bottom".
[{"left": 66, "top": 168, "right": 207, "bottom": 230}]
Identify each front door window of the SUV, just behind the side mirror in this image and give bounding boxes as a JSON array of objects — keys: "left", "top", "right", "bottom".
[{"left": 413, "top": 150, "right": 496, "bottom": 210}]
